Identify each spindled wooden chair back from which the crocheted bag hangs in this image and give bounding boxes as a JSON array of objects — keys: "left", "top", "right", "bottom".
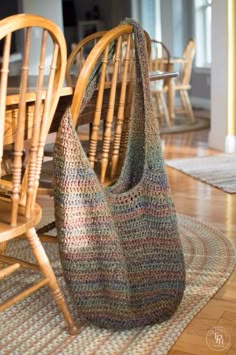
[{"left": 71, "top": 25, "right": 149, "bottom": 183}]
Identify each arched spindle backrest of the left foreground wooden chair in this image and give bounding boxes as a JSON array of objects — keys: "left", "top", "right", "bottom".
[{"left": 0, "top": 14, "right": 66, "bottom": 225}]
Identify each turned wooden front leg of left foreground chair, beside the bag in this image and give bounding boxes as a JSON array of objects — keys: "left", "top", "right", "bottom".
[{"left": 26, "top": 228, "right": 79, "bottom": 335}]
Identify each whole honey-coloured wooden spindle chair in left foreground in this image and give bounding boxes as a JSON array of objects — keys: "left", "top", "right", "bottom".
[{"left": 0, "top": 14, "right": 78, "bottom": 334}]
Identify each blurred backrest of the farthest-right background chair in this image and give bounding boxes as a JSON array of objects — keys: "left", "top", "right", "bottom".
[{"left": 178, "top": 38, "right": 196, "bottom": 85}]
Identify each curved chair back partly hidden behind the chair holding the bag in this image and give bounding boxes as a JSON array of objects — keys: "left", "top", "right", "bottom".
[{"left": 66, "top": 31, "right": 106, "bottom": 86}]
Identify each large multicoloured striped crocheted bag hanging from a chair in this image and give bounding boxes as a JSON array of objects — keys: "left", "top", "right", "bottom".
[{"left": 54, "top": 21, "right": 185, "bottom": 329}]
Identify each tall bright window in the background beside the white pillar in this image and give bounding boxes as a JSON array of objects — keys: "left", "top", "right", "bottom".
[{"left": 195, "top": 0, "right": 212, "bottom": 68}]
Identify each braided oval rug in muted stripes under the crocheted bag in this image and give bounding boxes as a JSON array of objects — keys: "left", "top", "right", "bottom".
[{"left": 0, "top": 210, "right": 235, "bottom": 355}]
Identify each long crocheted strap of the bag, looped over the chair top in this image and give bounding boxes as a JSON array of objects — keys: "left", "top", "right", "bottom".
[{"left": 122, "top": 18, "right": 162, "bottom": 169}]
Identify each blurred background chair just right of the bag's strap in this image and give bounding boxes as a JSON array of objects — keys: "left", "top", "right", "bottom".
[{"left": 150, "top": 39, "right": 171, "bottom": 127}]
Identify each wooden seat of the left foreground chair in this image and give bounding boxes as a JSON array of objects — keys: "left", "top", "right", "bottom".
[{"left": 0, "top": 197, "right": 42, "bottom": 243}]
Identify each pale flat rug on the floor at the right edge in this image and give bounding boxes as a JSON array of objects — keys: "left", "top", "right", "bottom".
[{"left": 165, "top": 154, "right": 236, "bottom": 194}]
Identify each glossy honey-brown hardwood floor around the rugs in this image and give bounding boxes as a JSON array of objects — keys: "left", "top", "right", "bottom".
[{"left": 39, "top": 124, "right": 236, "bottom": 355}]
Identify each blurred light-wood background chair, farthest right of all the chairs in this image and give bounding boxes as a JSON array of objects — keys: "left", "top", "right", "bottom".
[{"left": 174, "top": 39, "right": 196, "bottom": 121}]
